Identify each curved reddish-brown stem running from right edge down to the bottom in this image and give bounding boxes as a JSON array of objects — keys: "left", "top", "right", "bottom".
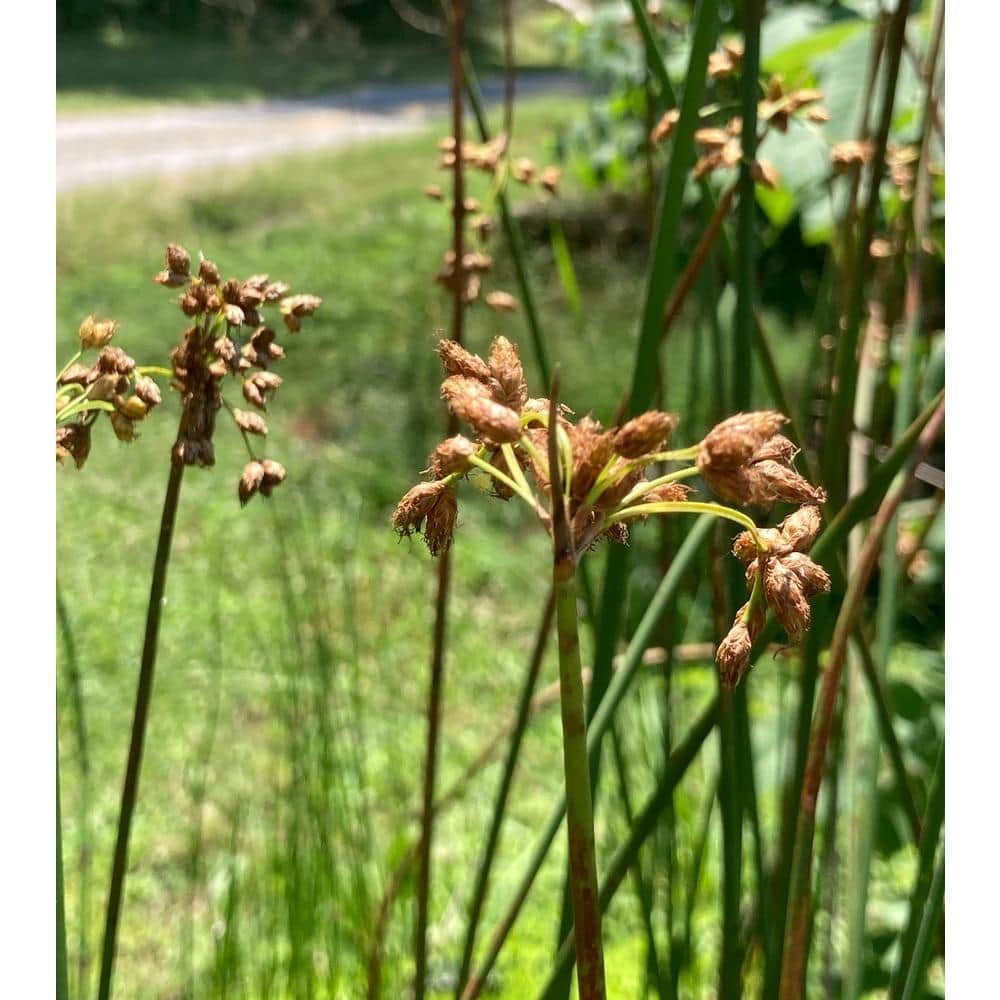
[{"left": 779, "top": 403, "right": 944, "bottom": 1000}]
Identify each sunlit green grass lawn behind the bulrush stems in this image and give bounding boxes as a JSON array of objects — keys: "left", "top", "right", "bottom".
[{"left": 57, "top": 95, "right": 844, "bottom": 998}]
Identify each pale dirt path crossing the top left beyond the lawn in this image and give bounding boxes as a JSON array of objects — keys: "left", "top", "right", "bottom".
[{"left": 56, "top": 74, "right": 582, "bottom": 192}]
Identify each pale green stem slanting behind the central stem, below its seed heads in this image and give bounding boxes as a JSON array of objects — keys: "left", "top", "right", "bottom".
[{"left": 462, "top": 516, "right": 713, "bottom": 1000}]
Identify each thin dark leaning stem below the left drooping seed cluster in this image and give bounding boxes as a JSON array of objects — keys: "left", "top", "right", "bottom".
[{"left": 97, "top": 456, "right": 184, "bottom": 1000}]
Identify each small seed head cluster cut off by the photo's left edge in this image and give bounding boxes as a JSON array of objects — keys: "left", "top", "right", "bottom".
[{"left": 56, "top": 316, "right": 161, "bottom": 469}]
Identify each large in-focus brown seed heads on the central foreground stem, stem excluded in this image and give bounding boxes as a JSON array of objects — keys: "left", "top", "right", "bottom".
[{"left": 392, "top": 337, "right": 830, "bottom": 685}]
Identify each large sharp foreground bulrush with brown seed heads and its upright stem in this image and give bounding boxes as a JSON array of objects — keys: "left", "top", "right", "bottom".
[{"left": 392, "top": 337, "right": 830, "bottom": 1000}]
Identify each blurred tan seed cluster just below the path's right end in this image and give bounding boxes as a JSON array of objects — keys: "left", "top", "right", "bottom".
[{"left": 424, "top": 133, "right": 562, "bottom": 312}]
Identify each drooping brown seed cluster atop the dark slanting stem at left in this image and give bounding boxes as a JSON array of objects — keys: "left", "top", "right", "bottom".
[{"left": 154, "top": 243, "right": 321, "bottom": 504}]
